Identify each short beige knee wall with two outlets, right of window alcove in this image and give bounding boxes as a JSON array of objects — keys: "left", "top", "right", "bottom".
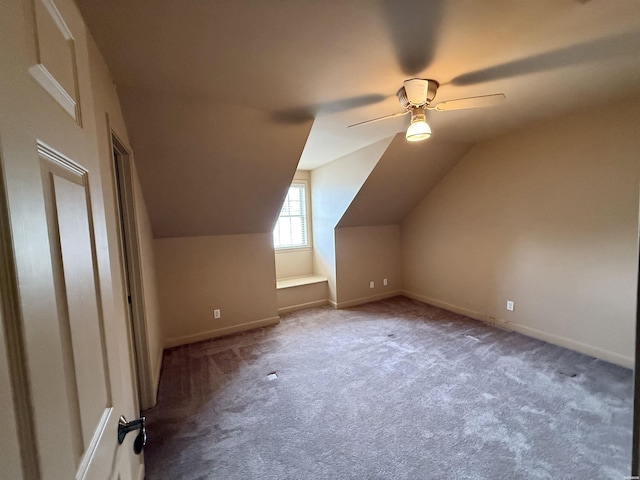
[{"left": 336, "top": 225, "right": 402, "bottom": 308}]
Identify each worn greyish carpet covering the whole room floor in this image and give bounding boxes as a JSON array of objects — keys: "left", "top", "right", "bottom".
[{"left": 145, "top": 297, "right": 633, "bottom": 480}]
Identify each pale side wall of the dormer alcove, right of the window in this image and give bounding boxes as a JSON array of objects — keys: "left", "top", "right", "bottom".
[{"left": 311, "top": 137, "right": 393, "bottom": 305}]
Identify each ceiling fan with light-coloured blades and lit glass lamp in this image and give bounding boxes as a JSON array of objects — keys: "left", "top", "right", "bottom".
[{"left": 347, "top": 78, "right": 507, "bottom": 142}]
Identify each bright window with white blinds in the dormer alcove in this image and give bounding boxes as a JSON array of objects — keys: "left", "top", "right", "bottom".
[{"left": 273, "top": 183, "right": 309, "bottom": 249}]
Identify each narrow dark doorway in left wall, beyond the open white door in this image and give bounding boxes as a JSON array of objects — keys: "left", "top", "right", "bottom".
[{"left": 111, "top": 133, "right": 155, "bottom": 410}]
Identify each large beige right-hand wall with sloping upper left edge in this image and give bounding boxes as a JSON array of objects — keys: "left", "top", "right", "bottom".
[{"left": 402, "top": 99, "right": 640, "bottom": 366}]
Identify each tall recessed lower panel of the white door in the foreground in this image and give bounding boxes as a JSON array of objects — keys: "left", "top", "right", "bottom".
[{"left": 39, "top": 146, "right": 112, "bottom": 476}]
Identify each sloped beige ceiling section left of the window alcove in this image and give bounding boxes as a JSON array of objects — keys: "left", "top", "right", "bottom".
[{"left": 121, "top": 89, "right": 312, "bottom": 237}]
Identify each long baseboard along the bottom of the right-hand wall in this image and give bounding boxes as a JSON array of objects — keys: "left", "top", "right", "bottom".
[{"left": 402, "top": 291, "right": 635, "bottom": 368}]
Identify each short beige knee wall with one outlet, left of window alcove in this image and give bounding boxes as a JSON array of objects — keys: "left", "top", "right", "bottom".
[{"left": 155, "top": 233, "right": 279, "bottom": 346}]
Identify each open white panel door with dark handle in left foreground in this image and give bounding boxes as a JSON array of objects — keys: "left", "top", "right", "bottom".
[{"left": 0, "top": 0, "right": 143, "bottom": 480}]
